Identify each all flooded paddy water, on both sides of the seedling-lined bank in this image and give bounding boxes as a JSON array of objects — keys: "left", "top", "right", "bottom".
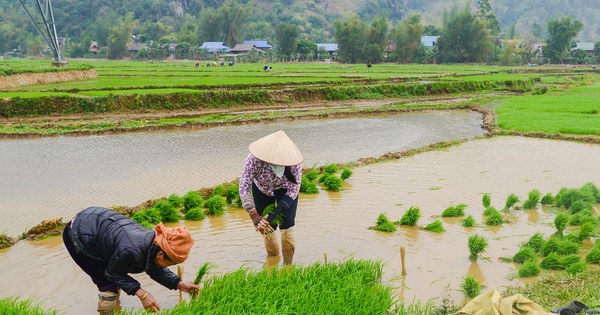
[{"left": 0, "top": 113, "right": 600, "bottom": 314}]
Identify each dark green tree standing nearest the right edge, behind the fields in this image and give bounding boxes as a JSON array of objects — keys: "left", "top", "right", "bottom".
[{"left": 542, "top": 16, "right": 583, "bottom": 63}]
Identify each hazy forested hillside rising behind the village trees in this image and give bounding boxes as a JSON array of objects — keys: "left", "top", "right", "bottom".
[{"left": 0, "top": 0, "right": 600, "bottom": 53}]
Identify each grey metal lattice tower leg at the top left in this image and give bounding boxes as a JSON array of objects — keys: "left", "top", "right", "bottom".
[{"left": 19, "top": 0, "right": 67, "bottom": 66}]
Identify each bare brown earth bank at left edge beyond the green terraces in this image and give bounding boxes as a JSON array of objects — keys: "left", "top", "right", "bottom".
[{"left": 0, "top": 69, "right": 98, "bottom": 89}]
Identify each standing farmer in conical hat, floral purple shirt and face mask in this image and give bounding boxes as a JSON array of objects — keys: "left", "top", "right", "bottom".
[{"left": 239, "top": 130, "right": 304, "bottom": 265}]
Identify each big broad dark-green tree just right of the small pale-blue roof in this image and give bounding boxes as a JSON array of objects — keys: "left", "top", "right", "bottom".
[{"left": 437, "top": 4, "right": 495, "bottom": 62}]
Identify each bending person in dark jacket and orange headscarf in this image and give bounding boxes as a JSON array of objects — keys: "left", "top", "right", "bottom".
[{"left": 63, "top": 207, "right": 198, "bottom": 315}]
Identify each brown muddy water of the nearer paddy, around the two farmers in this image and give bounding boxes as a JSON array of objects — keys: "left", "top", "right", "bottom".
[{"left": 0, "top": 115, "right": 600, "bottom": 314}]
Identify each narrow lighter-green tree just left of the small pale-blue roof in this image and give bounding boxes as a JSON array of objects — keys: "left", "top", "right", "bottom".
[{"left": 392, "top": 14, "right": 425, "bottom": 63}]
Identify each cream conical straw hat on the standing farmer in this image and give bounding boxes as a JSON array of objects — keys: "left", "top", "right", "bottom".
[{"left": 248, "top": 130, "right": 304, "bottom": 166}]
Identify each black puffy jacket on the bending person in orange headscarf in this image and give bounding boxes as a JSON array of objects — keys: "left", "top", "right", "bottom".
[{"left": 71, "top": 207, "right": 181, "bottom": 295}]
